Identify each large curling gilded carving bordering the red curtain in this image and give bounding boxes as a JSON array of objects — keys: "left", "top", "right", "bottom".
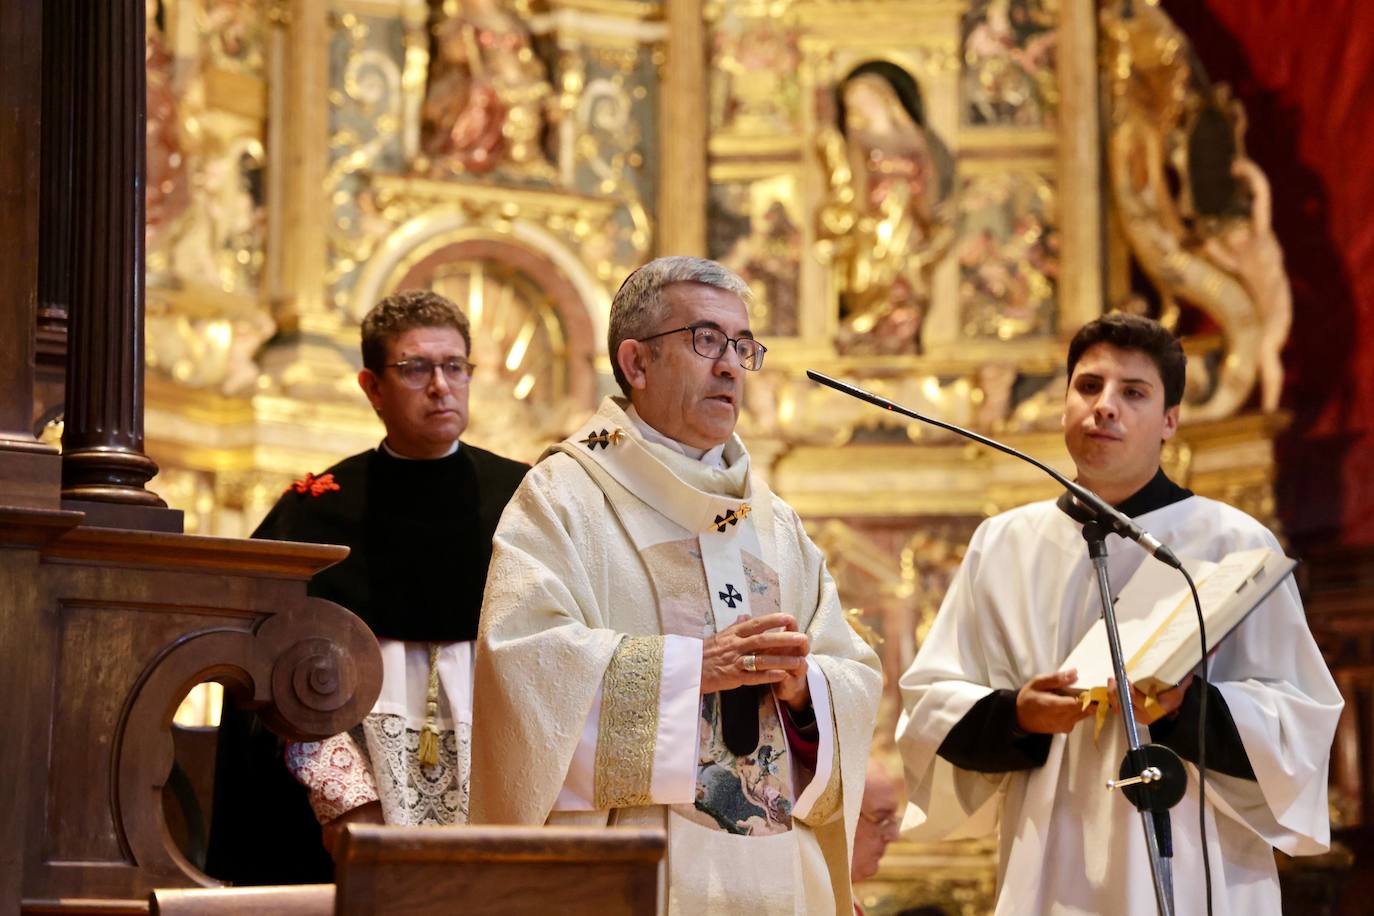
[{"left": 1103, "top": 4, "right": 1293, "bottom": 419}]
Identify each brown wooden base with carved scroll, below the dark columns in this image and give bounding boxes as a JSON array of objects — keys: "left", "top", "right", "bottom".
[{"left": 0, "top": 507, "right": 382, "bottom": 912}]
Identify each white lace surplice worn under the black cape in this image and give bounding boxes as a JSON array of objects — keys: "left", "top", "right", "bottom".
[{"left": 286, "top": 640, "right": 473, "bottom": 825}]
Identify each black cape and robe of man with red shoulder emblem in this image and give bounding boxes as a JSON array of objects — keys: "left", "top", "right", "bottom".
[{"left": 206, "top": 444, "right": 529, "bottom": 884}]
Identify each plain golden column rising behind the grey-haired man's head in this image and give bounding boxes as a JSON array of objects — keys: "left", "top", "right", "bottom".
[{"left": 654, "top": 0, "right": 706, "bottom": 257}]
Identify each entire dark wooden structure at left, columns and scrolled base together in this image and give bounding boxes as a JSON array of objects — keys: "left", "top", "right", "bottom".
[{"left": 0, "top": 0, "right": 382, "bottom": 916}]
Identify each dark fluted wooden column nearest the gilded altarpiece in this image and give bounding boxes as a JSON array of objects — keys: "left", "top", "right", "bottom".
[{"left": 55, "top": 0, "right": 165, "bottom": 507}]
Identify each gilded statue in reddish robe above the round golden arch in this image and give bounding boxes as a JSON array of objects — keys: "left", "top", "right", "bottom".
[{"left": 420, "top": 0, "right": 554, "bottom": 180}]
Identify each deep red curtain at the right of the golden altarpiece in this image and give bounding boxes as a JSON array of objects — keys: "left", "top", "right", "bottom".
[{"left": 1165, "top": 0, "right": 1374, "bottom": 548}]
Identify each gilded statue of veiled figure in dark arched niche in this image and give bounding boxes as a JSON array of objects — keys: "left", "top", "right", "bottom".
[{"left": 818, "top": 60, "right": 955, "bottom": 353}]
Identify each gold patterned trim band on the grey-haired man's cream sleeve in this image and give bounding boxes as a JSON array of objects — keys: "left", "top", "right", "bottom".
[{"left": 592, "top": 636, "right": 664, "bottom": 809}]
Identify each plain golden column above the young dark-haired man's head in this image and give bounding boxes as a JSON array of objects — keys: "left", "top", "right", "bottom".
[{"left": 1059, "top": 0, "right": 1106, "bottom": 338}]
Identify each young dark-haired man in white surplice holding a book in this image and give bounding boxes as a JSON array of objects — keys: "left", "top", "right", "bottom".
[{"left": 897, "top": 314, "right": 1341, "bottom": 916}]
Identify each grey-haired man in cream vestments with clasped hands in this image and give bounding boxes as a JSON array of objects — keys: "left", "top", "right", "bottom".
[{"left": 471, "top": 257, "right": 881, "bottom": 916}]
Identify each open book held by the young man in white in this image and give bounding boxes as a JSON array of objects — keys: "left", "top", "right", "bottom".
[{"left": 1059, "top": 547, "right": 1297, "bottom": 696}]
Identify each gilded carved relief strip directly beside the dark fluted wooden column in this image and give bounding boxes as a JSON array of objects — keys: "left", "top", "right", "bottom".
[{"left": 146, "top": 0, "right": 275, "bottom": 394}]
